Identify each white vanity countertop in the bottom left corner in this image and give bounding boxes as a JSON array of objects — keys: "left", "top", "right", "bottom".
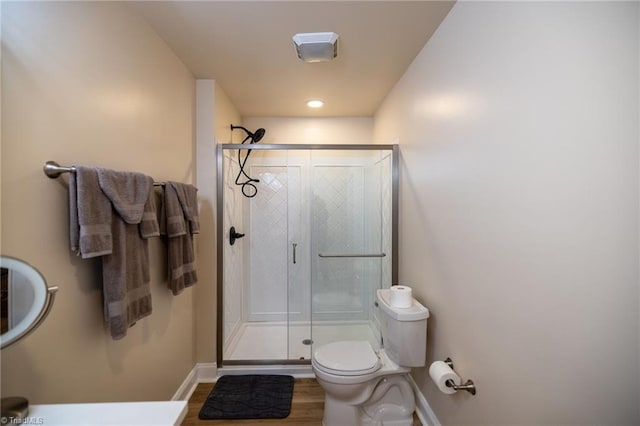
[{"left": 27, "top": 401, "right": 187, "bottom": 426}]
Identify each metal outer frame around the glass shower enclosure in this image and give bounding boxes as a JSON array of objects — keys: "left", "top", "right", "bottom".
[{"left": 216, "top": 144, "right": 400, "bottom": 368}]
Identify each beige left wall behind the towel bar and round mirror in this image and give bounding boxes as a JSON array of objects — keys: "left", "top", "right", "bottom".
[{"left": 1, "top": 2, "right": 195, "bottom": 403}]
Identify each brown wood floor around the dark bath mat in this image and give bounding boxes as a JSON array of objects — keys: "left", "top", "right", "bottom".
[{"left": 182, "top": 379, "right": 422, "bottom": 426}]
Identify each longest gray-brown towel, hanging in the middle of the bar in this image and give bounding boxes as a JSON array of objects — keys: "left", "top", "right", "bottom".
[{"left": 97, "top": 169, "right": 158, "bottom": 339}]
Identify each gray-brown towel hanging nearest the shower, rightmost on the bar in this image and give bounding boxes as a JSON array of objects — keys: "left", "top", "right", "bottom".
[{"left": 163, "top": 182, "right": 200, "bottom": 295}]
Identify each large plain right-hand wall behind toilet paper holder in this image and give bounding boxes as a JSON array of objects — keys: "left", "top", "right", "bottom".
[{"left": 374, "top": 2, "right": 640, "bottom": 426}]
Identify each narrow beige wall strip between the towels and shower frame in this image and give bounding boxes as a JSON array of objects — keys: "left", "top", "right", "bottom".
[{"left": 196, "top": 80, "right": 241, "bottom": 363}]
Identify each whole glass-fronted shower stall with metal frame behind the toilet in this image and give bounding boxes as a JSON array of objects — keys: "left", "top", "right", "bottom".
[{"left": 217, "top": 144, "right": 398, "bottom": 366}]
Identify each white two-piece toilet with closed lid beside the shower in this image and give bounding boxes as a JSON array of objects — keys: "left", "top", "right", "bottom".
[{"left": 311, "top": 289, "right": 429, "bottom": 426}]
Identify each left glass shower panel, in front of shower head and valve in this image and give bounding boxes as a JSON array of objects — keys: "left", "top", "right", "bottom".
[{"left": 220, "top": 149, "right": 301, "bottom": 363}]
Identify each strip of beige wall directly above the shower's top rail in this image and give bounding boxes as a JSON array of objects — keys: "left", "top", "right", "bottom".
[{"left": 240, "top": 117, "right": 373, "bottom": 144}]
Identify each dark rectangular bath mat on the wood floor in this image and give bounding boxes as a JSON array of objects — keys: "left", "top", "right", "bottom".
[{"left": 198, "top": 374, "right": 293, "bottom": 420}]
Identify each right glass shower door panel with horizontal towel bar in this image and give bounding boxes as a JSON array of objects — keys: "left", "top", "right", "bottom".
[{"left": 310, "top": 150, "right": 392, "bottom": 352}]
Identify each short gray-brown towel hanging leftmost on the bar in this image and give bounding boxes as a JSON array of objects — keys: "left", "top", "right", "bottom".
[{"left": 69, "top": 166, "right": 113, "bottom": 259}]
